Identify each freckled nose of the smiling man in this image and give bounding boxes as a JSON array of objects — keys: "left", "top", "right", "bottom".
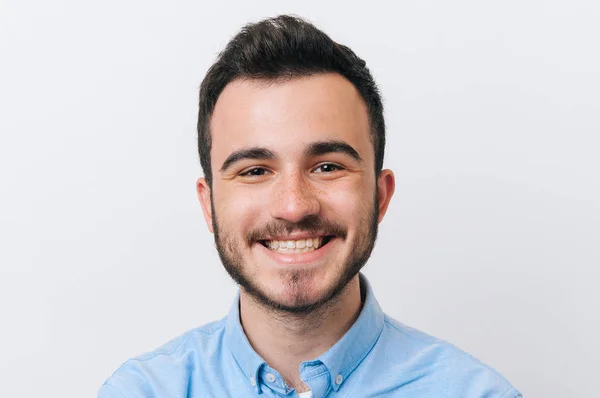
[{"left": 269, "top": 172, "right": 321, "bottom": 222}]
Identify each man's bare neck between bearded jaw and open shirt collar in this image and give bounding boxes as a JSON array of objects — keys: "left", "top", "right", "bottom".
[{"left": 240, "top": 275, "right": 362, "bottom": 392}]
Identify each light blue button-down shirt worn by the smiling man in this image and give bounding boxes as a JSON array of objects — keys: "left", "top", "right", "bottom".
[{"left": 98, "top": 274, "right": 521, "bottom": 398}]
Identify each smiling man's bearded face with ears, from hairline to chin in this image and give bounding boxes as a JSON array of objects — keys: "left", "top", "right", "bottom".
[{"left": 198, "top": 74, "right": 393, "bottom": 313}]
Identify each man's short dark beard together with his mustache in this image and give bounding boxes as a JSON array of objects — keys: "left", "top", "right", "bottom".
[{"left": 211, "top": 189, "right": 379, "bottom": 315}]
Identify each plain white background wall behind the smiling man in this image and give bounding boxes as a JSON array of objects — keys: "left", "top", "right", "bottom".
[{"left": 0, "top": 0, "right": 600, "bottom": 398}]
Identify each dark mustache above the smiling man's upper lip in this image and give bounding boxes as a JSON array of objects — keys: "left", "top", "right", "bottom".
[{"left": 246, "top": 215, "right": 348, "bottom": 245}]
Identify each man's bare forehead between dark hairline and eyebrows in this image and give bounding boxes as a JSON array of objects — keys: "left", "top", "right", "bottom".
[{"left": 210, "top": 74, "right": 373, "bottom": 163}]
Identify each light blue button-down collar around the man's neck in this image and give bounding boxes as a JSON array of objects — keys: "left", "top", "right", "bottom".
[{"left": 225, "top": 273, "right": 385, "bottom": 393}]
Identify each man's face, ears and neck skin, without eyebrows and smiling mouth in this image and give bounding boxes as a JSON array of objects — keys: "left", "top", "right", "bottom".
[{"left": 197, "top": 74, "right": 395, "bottom": 392}]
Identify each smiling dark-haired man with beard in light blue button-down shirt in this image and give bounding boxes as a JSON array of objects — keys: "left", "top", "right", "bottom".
[{"left": 99, "top": 16, "right": 521, "bottom": 398}]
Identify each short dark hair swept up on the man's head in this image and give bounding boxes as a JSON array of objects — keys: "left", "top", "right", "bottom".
[{"left": 198, "top": 15, "right": 385, "bottom": 186}]
